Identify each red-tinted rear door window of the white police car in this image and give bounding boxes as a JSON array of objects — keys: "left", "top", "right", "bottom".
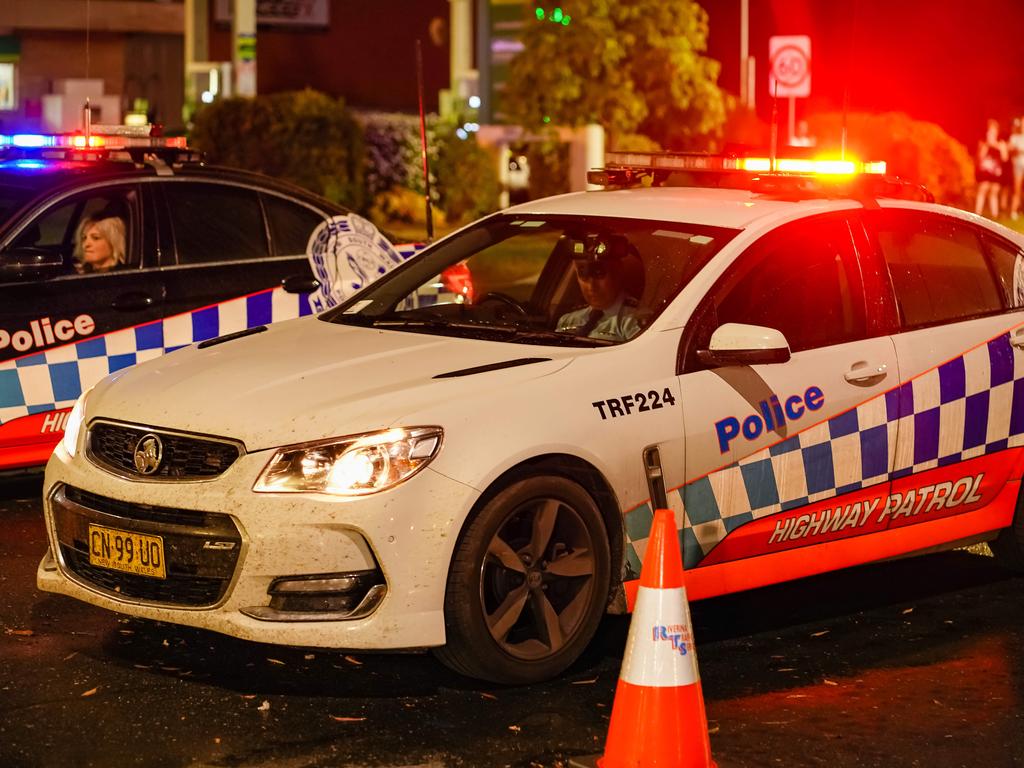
[{"left": 866, "top": 210, "right": 1008, "bottom": 329}]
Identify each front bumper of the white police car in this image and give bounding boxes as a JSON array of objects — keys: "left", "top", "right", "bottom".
[{"left": 37, "top": 446, "right": 477, "bottom": 649}]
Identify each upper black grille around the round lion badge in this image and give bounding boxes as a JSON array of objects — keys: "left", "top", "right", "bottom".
[{"left": 88, "top": 422, "right": 241, "bottom": 480}]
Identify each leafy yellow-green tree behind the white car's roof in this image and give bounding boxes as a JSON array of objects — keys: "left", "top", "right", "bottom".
[{"left": 503, "top": 0, "right": 725, "bottom": 150}]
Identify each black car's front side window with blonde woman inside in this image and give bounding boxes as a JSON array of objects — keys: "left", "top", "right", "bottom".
[{"left": 4, "top": 186, "right": 138, "bottom": 273}]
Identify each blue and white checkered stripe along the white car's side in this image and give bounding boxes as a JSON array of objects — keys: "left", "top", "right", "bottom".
[{"left": 626, "top": 334, "right": 1024, "bottom": 573}]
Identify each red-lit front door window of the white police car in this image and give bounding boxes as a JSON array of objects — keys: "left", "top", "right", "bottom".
[{"left": 698, "top": 216, "right": 866, "bottom": 352}]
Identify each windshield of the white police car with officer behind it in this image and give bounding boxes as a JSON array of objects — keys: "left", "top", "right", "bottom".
[{"left": 321, "top": 215, "right": 737, "bottom": 346}]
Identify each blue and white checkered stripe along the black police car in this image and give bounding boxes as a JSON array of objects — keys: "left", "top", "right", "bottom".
[{"left": 0, "top": 244, "right": 423, "bottom": 424}]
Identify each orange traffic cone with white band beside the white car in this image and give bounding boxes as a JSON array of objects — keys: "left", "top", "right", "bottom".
[{"left": 597, "top": 509, "right": 715, "bottom": 768}]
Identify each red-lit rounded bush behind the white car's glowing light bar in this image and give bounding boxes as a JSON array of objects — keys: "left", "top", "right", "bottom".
[{"left": 808, "top": 112, "right": 975, "bottom": 206}]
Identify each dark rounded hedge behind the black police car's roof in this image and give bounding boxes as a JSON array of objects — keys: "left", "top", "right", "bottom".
[{"left": 191, "top": 90, "right": 367, "bottom": 210}]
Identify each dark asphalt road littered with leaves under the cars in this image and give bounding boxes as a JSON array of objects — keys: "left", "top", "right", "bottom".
[{"left": 0, "top": 482, "right": 1024, "bottom": 768}]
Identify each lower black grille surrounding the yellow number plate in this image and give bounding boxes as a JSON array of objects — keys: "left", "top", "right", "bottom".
[{"left": 50, "top": 485, "right": 242, "bottom": 607}]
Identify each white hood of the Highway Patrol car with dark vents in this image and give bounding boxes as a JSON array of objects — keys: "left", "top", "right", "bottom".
[{"left": 86, "top": 317, "right": 580, "bottom": 452}]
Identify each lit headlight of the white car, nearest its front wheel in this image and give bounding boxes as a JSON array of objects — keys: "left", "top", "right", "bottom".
[{"left": 253, "top": 427, "right": 443, "bottom": 496}]
